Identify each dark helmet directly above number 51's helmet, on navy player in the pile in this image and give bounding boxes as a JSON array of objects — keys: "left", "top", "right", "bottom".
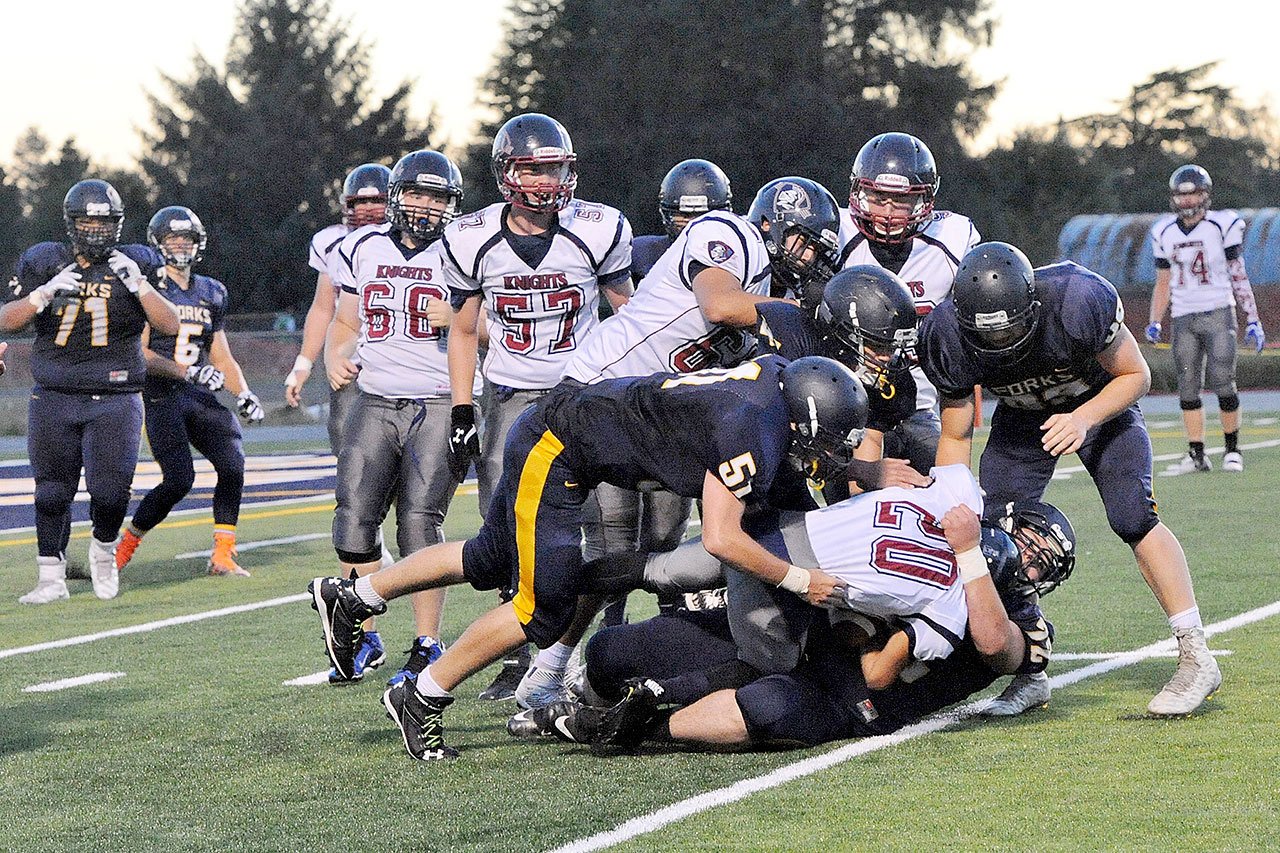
[{"left": 814, "top": 264, "right": 916, "bottom": 384}]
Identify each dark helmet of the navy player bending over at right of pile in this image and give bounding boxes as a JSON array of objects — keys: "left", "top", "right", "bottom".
[{"left": 951, "top": 242, "right": 1041, "bottom": 366}]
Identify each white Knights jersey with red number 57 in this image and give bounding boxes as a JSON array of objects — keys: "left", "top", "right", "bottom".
[{"left": 440, "top": 199, "right": 631, "bottom": 389}]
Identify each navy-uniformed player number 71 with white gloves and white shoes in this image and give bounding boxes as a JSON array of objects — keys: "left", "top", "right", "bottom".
[{"left": 0, "top": 178, "right": 179, "bottom": 605}]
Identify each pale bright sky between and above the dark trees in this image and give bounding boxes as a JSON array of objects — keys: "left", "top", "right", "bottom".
[{"left": 0, "top": 0, "right": 1280, "bottom": 165}]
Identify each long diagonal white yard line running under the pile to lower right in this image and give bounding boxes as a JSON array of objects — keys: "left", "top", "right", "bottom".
[{"left": 553, "top": 601, "right": 1280, "bottom": 853}]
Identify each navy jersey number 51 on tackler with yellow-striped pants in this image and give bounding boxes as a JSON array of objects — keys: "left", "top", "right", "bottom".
[{"left": 545, "top": 355, "right": 812, "bottom": 508}]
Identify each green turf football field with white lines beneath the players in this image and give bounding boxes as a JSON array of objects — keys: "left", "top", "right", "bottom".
[{"left": 0, "top": 412, "right": 1280, "bottom": 850}]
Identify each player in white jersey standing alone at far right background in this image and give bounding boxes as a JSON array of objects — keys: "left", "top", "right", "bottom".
[{"left": 1147, "top": 165, "right": 1267, "bottom": 474}]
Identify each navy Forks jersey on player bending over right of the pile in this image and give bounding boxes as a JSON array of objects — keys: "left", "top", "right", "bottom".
[{"left": 916, "top": 261, "right": 1124, "bottom": 412}]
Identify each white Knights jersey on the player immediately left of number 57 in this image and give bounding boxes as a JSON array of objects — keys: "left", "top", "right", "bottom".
[{"left": 334, "top": 224, "right": 480, "bottom": 400}]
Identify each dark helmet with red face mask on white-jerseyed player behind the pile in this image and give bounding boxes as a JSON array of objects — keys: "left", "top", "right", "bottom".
[{"left": 849, "top": 133, "right": 940, "bottom": 243}]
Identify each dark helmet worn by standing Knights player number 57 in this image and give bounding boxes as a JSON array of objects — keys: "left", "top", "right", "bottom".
[{"left": 492, "top": 113, "right": 577, "bottom": 213}]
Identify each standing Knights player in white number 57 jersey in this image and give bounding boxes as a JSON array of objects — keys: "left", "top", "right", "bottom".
[{"left": 443, "top": 113, "right": 632, "bottom": 699}]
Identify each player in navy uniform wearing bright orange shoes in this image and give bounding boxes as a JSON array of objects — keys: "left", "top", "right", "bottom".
[{"left": 115, "top": 206, "right": 265, "bottom": 578}]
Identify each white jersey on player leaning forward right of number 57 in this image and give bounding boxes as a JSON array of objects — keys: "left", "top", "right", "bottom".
[{"left": 564, "top": 210, "right": 769, "bottom": 384}]
